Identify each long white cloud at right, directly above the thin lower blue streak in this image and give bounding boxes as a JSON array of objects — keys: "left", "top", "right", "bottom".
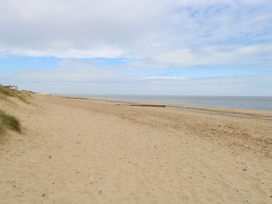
[{"left": 130, "top": 44, "right": 272, "bottom": 68}]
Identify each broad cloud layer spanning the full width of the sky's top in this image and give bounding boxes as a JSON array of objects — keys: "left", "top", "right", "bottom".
[{"left": 0, "top": 0, "right": 272, "bottom": 57}]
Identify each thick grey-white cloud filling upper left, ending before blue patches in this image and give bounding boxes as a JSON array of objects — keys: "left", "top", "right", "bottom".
[{"left": 0, "top": 0, "right": 167, "bottom": 50}]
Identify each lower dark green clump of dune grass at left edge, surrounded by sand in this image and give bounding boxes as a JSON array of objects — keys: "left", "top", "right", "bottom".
[{"left": 0, "top": 110, "right": 22, "bottom": 134}]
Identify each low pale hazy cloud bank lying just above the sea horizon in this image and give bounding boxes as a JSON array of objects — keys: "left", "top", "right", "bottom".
[{"left": 10, "top": 68, "right": 272, "bottom": 96}]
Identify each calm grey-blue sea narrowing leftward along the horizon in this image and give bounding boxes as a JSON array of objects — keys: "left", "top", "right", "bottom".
[{"left": 85, "top": 95, "right": 272, "bottom": 111}]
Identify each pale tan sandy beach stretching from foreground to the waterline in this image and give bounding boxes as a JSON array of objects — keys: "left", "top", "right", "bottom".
[{"left": 0, "top": 95, "right": 272, "bottom": 204}]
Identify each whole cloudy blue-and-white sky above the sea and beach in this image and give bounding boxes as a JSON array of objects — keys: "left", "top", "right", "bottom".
[{"left": 0, "top": 0, "right": 272, "bottom": 96}]
